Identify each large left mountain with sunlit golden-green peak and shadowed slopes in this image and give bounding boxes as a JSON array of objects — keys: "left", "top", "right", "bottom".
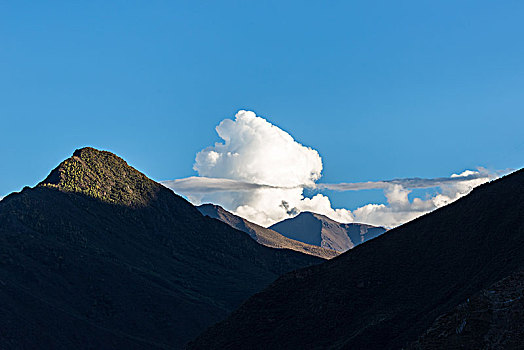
[{"left": 0, "top": 148, "right": 322, "bottom": 349}]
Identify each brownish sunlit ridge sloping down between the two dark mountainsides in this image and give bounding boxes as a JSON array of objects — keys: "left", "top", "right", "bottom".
[{"left": 197, "top": 204, "right": 339, "bottom": 259}]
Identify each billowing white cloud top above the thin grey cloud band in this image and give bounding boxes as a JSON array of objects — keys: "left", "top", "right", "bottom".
[{"left": 193, "top": 111, "right": 322, "bottom": 187}]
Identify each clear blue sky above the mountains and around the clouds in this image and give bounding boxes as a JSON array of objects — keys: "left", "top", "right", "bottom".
[{"left": 0, "top": 0, "right": 524, "bottom": 211}]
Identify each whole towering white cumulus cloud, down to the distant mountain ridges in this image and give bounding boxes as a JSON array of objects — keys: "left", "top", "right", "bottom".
[{"left": 176, "top": 111, "right": 353, "bottom": 226}]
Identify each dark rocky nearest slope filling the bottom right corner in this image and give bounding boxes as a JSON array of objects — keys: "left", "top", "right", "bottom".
[{"left": 408, "top": 271, "right": 524, "bottom": 350}]
